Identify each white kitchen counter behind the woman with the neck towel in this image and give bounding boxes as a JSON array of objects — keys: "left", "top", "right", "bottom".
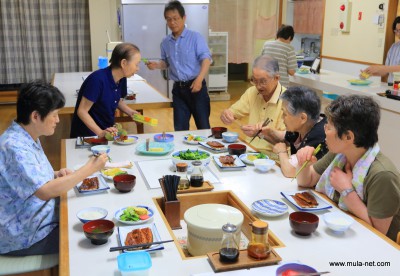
[{"left": 290, "top": 69, "right": 400, "bottom": 170}]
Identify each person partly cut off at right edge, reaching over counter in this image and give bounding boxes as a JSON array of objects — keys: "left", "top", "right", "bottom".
[{"left": 360, "top": 16, "right": 400, "bottom": 83}]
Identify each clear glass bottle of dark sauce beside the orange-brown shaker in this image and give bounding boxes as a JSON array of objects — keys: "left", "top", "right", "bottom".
[{"left": 219, "top": 222, "right": 239, "bottom": 263}]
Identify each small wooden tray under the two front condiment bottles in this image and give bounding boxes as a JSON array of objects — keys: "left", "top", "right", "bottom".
[{"left": 207, "top": 249, "right": 282, "bottom": 272}]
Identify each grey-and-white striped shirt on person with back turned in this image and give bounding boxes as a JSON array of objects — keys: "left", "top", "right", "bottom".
[{"left": 262, "top": 40, "right": 297, "bottom": 87}]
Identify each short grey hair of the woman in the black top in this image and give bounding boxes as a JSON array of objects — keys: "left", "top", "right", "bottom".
[{"left": 280, "top": 86, "right": 321, "bottom": 123}]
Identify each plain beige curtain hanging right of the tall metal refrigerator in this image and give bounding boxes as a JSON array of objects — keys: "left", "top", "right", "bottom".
[{"left": 209, "top": 0, "right": 279, "bottom": 63}]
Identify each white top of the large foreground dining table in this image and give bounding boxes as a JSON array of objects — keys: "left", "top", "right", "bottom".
[{"left": 59, "top": 130, "right": 400, "bottom": 276}]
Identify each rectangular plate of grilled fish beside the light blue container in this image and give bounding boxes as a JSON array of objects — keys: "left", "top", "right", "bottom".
[{"left": 118, "top": 223, "right": 164, "bottom": 252}]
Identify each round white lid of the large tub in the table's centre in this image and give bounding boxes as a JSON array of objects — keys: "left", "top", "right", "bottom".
[{"left": 183, "top": 204, "right": 243, "bottom": 230}]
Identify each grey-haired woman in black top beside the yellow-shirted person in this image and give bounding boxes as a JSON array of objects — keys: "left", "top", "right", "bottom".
[{"left": 257, "top": 86, "right": 328, "bottom": 177}]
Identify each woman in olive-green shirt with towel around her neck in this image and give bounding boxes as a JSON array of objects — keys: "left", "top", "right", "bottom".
[{"left": 297, "top": 95, "right": 400, "bottom": 240}]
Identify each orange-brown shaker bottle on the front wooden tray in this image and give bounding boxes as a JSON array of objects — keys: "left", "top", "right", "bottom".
[{"left": 247, "top": 220, "right": 271, "bottom": 260}]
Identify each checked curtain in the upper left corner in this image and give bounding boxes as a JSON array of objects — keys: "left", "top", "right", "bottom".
[{"left": 0, "top": 0, "right": 91, "bottom": 84}]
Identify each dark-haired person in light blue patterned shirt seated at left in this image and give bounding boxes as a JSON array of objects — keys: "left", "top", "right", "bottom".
[{"left": 0, "top": 82, "right": 107, "bottom": 256}]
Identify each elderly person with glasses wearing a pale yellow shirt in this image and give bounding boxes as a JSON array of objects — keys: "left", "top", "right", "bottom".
[{"left": 220, "top": 55, "right": 286, "bottom": 151}]
